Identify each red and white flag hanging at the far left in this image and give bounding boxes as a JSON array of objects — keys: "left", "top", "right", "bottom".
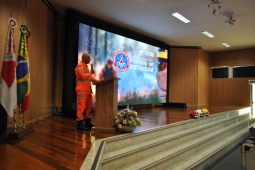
[{"left": 0, "top": 18, "right": 17, "bottom": 117}]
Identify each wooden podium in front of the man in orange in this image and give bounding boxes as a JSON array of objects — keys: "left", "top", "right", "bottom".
[{"left": 91, "top": 77, "right": 120, "bottom": 133}]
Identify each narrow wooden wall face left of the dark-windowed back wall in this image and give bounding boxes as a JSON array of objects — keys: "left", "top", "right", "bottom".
[{"left": 198, "top": 49, "right": 211, "bottom": 105}]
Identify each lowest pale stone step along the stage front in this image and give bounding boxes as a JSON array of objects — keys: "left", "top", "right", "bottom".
[{"left": 128, "top": 120, "right": 254, "bottom": 170}]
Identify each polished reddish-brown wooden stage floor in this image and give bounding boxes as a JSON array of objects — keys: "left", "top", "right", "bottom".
[{"left": 0, "top": 106, "right": 247, "bottom": 170}]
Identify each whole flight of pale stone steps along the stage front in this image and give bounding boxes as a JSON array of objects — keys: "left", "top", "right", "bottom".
[{"left": 81, "top": 108, "right": 254, "bottom": 170}]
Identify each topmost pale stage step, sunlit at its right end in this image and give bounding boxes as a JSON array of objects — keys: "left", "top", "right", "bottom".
[{"left": 104, "top": 109, "right": 250, "bottom": 153}]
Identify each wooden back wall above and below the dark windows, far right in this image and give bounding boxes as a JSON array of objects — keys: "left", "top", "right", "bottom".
[{"left": 210, "top": 48, "right": 255, "bottom": 106}]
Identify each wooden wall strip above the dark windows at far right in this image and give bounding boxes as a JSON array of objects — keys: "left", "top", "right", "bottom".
[{"left": 211, "top": 48, "right": 255, "bottom": 67}]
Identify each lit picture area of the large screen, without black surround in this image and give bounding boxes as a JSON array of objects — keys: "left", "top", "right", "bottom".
[{"left": 78, "top": 23, "right": 167, "bottom": 105}]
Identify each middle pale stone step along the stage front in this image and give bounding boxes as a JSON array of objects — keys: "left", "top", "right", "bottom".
[{"left": 102, "top": 114, "right": 249, "bottom": 169}]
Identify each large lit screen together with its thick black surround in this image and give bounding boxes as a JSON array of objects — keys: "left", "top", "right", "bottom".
[{"left": 62, "top": 10, "right": 170, "bottom": 116}]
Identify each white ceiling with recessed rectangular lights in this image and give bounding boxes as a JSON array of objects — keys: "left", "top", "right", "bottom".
[{"left": 48, "top": 0, "right": 255, "bottom": 52}]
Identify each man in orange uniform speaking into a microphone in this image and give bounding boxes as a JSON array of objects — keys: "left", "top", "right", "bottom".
[{"left": 75, "top": 53, "right": 98, "bottom": 130}]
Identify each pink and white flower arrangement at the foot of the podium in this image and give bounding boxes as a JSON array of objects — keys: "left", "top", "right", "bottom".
[{"left": 113, "top": 108, "right": 142, "bottom": 129}]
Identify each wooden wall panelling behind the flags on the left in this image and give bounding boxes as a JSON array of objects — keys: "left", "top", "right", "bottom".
[{"left": 0, "top": 0, "right": 55, "bottom": 123}]
